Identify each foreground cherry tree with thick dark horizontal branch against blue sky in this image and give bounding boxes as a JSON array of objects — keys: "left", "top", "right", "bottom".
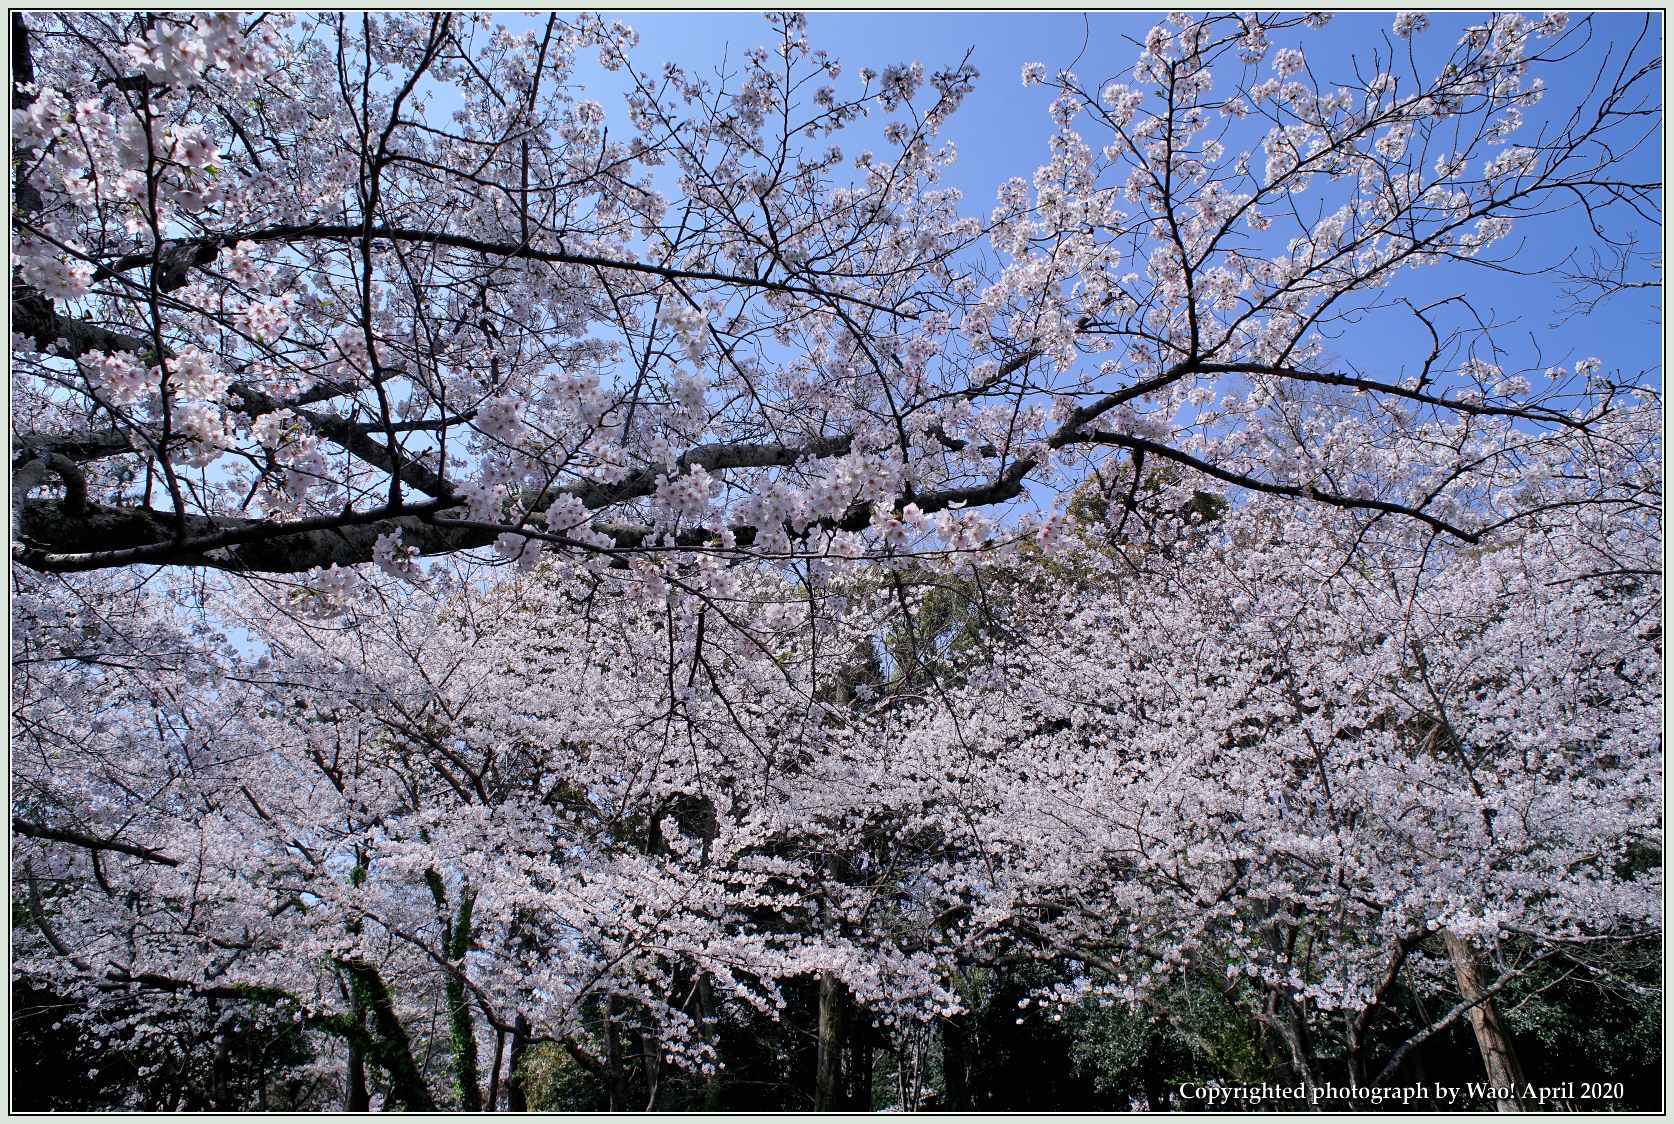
[{"left": 13, "top": 13, "right": 1659, "bottom": 573}]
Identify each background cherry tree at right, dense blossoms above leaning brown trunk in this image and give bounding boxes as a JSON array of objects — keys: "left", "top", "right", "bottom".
[{"left": 876, "top": 400, "right": 1662, "bottom": 1107}]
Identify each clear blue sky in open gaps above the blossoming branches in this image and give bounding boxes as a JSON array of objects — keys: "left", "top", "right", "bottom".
[{"left": 552, "top": 12, "right": 1662, "bottom": 385}]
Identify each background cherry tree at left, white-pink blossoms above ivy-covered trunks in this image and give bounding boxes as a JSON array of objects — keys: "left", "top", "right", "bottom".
[{"left": 13, "top": 552, "right": 977, "bottom": 1109}]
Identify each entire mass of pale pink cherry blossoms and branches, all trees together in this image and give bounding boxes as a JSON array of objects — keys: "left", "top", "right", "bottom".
[{"left": 12, "top": 12, "right": 1662, "bottom": 1109}]
